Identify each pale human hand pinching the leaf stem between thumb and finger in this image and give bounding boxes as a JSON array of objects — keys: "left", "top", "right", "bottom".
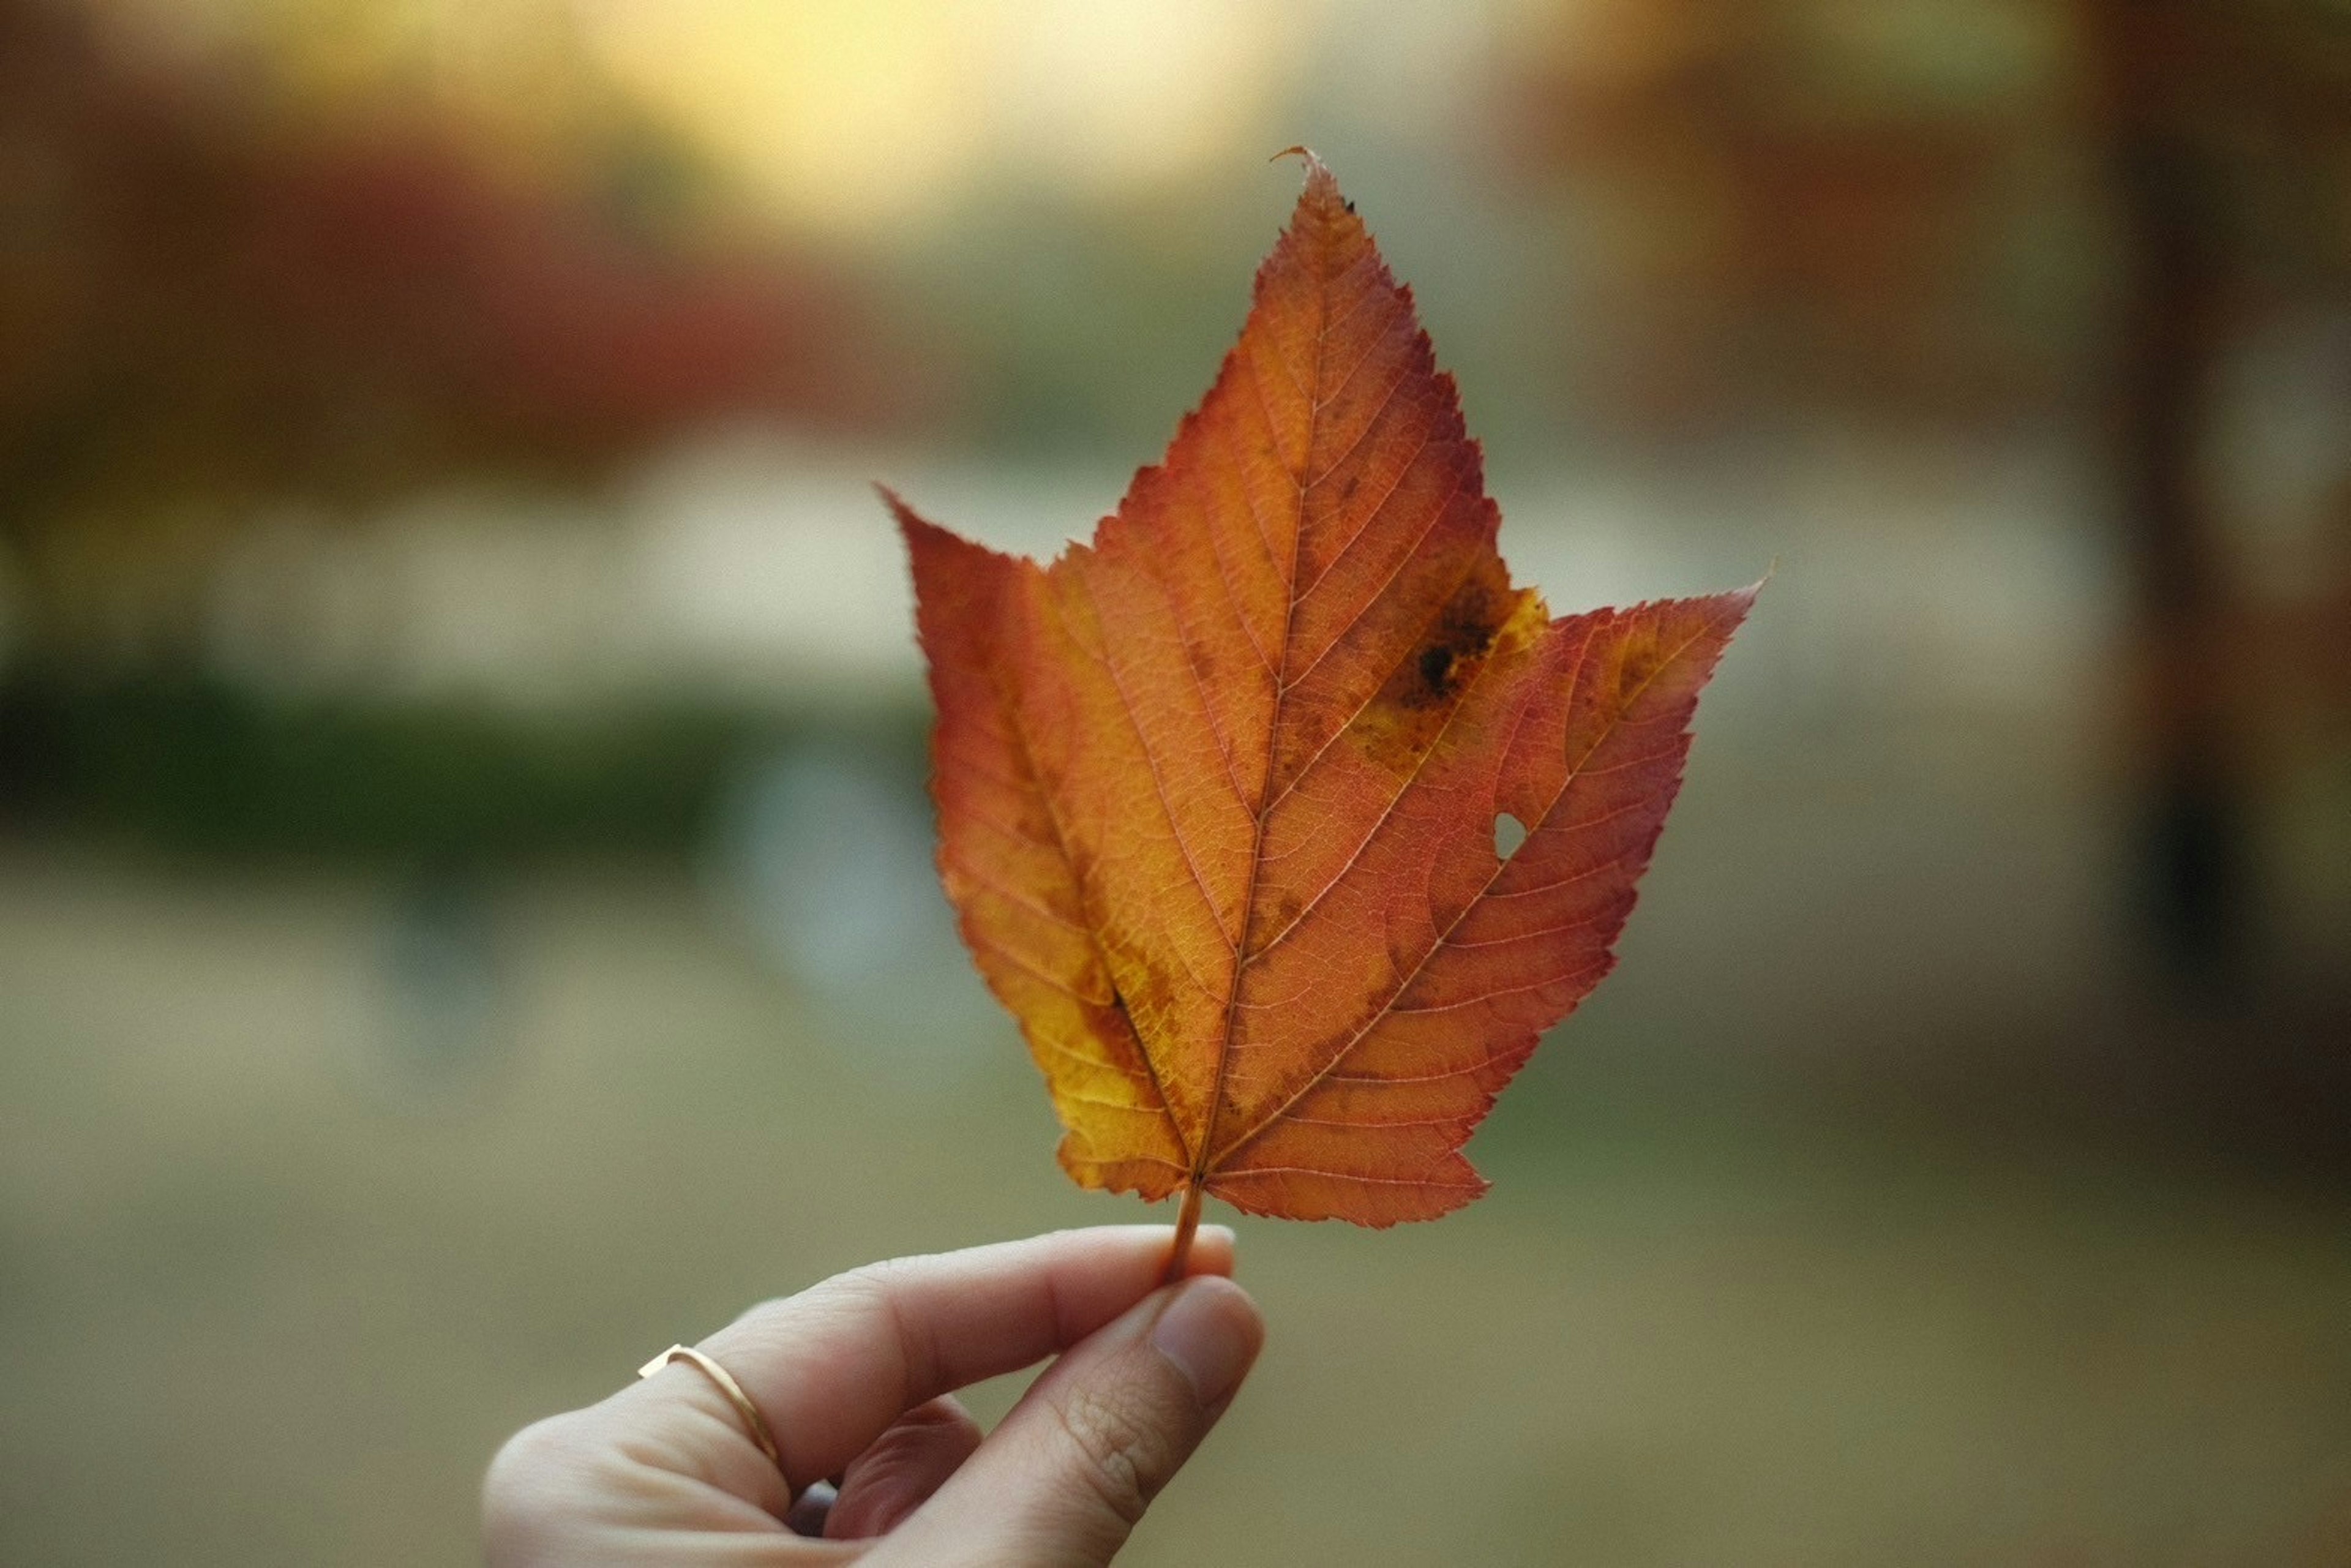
[{"left": 482, "top": 1225, "right": 1265, "bottom": 1568}]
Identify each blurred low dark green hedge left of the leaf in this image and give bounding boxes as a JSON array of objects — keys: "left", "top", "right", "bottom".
[{"left": 0, "top": 672, "right": 865, "bottom": 860}]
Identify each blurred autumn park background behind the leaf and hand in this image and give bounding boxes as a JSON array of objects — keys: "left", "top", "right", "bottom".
[{"left": 0, "top": 0, "right": 2351, "bottom": 1568}]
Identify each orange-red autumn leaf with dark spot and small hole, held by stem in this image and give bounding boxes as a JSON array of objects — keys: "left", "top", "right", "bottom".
[{"left": 889, "top": 155, "right": 1754, "bottom": 1269}]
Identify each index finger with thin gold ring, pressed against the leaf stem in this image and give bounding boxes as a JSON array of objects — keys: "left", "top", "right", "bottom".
[{"left": 602, "top": 1225, "right": 1232, "bottom": 1509}]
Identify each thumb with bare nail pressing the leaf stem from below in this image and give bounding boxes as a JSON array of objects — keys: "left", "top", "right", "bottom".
[{"left": 874, "top": 1277, "right": 1265, "bottom": 1568}]
